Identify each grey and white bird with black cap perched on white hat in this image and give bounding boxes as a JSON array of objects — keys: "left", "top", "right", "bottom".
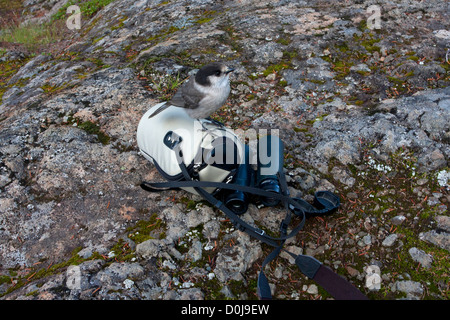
[{"left": 149, "top": 62, "right": 234, "bottom": 119}]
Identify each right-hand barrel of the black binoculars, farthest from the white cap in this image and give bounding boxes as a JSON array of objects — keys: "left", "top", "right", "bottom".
[{"left": 256, "top": 135, "right": 283, "bottom": 207}]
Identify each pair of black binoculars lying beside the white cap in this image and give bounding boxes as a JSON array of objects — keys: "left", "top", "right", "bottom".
[{"left": 223, "top": 135, "right": 284, "bottom": 215}]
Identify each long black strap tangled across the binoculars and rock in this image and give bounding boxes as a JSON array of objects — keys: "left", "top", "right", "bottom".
[{"left": 141, "top": 142, "right": 367, "bottom": 300}]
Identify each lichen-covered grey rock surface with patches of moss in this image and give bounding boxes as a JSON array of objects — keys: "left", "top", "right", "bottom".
[{"left": 0, "top": 0, "right": 450, "bottom": 300}]
